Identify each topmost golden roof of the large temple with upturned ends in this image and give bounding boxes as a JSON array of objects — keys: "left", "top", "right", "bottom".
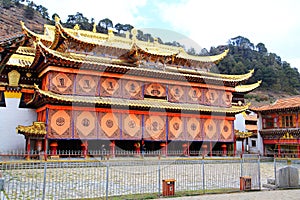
[{"left": 21, "top": 22, "right": 229, "bottom": 63}]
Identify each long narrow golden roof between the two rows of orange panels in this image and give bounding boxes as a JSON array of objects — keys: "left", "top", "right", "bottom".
[{"left": 35, "top": 85, "right": 250, "bottom": 114}]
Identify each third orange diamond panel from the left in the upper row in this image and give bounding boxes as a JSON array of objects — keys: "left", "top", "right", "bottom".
[{"left": 100, "top": 77, "right": 121, "bottom": 97}]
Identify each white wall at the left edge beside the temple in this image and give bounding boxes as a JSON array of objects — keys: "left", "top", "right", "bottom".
[{"left": 0, "top": 94, "right": 37, "bottom": 152}]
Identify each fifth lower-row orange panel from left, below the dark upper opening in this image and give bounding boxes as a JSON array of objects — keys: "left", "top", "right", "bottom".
[{"left": 144, "top": 115, "right": 166, "bottom": 140}]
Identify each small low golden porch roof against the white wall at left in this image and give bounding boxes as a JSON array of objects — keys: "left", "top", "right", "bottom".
[{"left": 16, "top": 122, "right": 47, "bottom": 136}]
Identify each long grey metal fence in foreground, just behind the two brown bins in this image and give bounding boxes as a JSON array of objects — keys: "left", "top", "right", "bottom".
[{"left": 0, "top": 157, "right": 261, "bottom": 200}]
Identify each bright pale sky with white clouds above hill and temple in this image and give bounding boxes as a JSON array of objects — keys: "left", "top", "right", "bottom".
[{"left": 33, "top": 0, "right": 300, "bottom": 72}]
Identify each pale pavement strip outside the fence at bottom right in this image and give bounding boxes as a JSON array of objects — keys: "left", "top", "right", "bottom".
[{"left": 157, "top": 189, "right": 300, "bottom": 200}]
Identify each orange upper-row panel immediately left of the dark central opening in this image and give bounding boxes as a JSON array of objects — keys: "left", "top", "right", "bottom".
[{"left": 122, "top": 80, "right": 143, "bottom": 99}]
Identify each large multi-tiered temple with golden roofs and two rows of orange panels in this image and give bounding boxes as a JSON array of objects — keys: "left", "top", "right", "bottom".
[{"left": 0, "top": 20, "right": 260, "bottom": 159}]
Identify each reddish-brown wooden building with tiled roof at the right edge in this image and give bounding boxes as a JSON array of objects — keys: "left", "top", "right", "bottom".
[{"left": 251, "top": 96, "right": 300, "bottom": 158}]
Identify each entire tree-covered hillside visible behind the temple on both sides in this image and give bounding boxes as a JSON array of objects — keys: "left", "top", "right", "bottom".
[{"left": 0, "top": 0, "right": 300, "bottom": 100}]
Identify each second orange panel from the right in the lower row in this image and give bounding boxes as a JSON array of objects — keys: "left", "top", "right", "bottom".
[{"left": 203, "top": 119, "right": 219, "bottom": 141}]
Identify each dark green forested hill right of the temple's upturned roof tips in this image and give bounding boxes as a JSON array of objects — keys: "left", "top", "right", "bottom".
[{"left": 210, "top": 36, "right": 300, "bottom": 95}]
